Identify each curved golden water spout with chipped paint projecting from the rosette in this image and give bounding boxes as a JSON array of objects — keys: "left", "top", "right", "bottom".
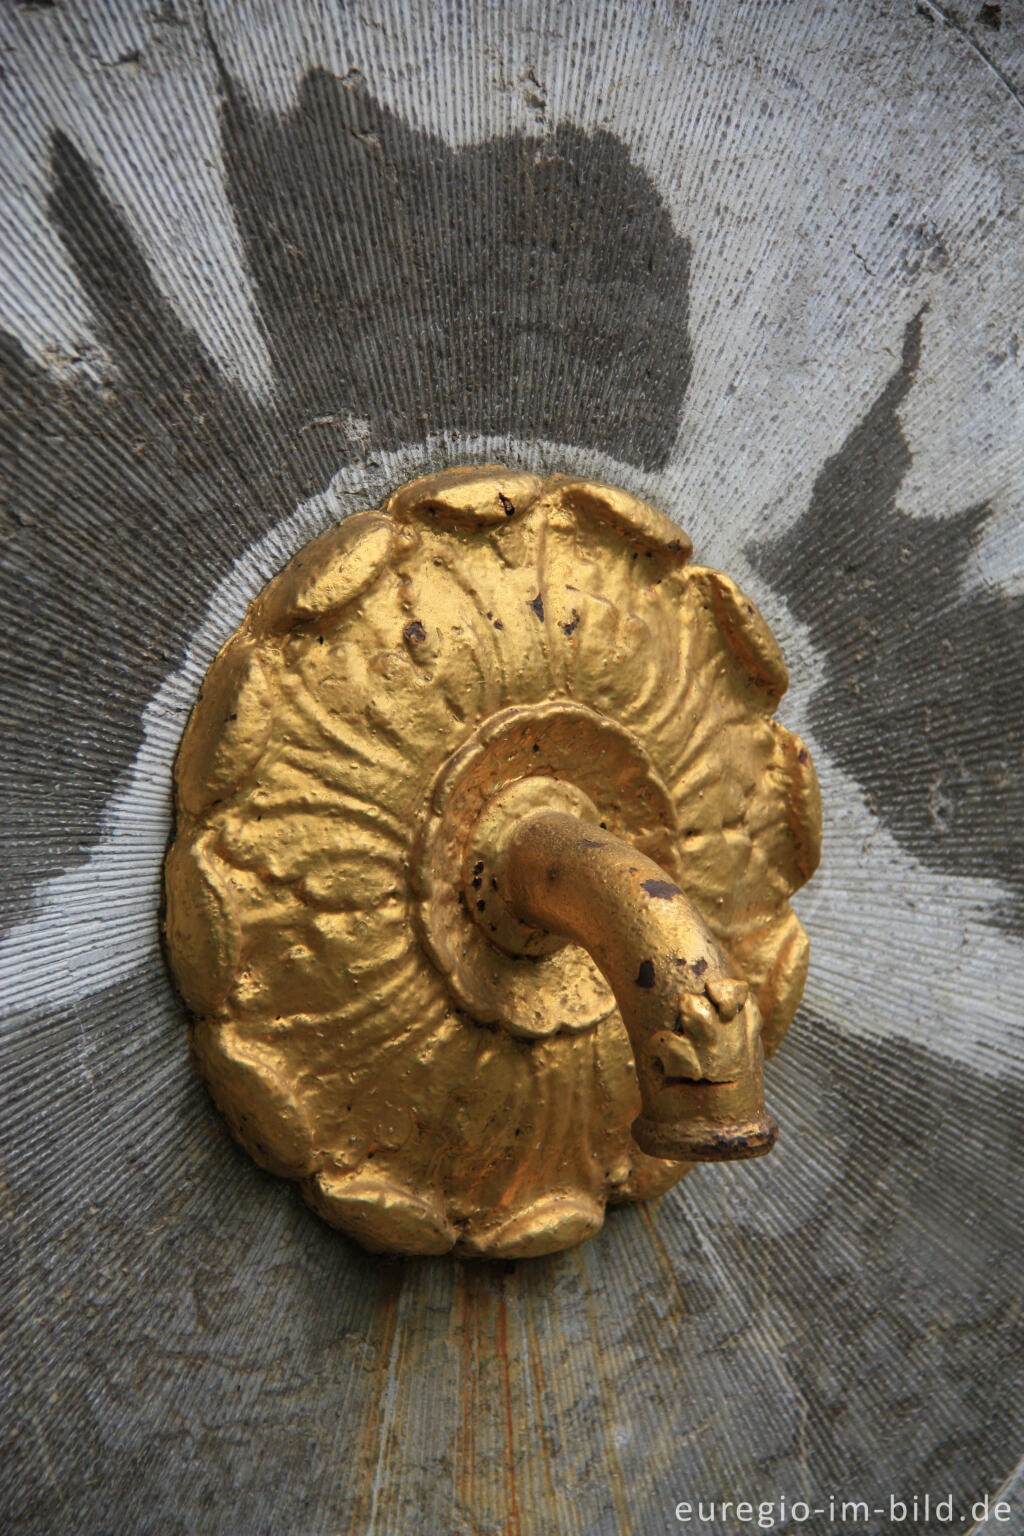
[{"left": 504, "top": 811, "right": 778, "bottom": 1161}]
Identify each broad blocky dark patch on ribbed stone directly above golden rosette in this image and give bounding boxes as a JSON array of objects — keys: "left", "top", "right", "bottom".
[{"left": 223, "top": 71, "right": 691, "bottom": 468}]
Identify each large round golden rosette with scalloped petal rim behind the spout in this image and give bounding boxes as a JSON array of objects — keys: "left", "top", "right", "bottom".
[{"left": 166, "top": 467, "right": 820, "bottom": 1258}]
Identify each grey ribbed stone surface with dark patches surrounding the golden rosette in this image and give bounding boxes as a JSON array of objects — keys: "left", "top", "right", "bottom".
[{"left": 0, "top": 0, "right": 1024, "bottom": 1536}]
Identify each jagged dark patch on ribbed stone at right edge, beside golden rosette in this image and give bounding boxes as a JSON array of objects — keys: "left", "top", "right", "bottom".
[{"left": 748, "top": 315, "right": 1024, "bottom": 925}]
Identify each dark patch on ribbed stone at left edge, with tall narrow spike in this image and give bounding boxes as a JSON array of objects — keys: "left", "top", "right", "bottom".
[{"left": 0, "top": 135, "right": 342, "bottom": 922}]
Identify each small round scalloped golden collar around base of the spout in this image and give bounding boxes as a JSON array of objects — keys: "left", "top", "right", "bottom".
[{"left": 411, "top": 700, "right": 679, "bottom": 1040}]
